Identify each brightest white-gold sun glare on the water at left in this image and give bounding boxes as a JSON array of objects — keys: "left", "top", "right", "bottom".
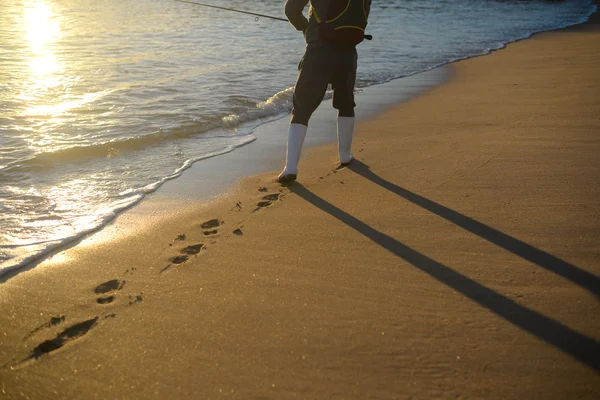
[{"left": 13, "top": 0, "right": 111, "bottom": 222}]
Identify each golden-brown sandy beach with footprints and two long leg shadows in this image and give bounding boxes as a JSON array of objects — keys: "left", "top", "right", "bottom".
[{"left": 0, "top": 15, "right": 600, "bottom": 399}]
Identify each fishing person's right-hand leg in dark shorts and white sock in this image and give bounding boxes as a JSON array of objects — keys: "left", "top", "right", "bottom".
[{"left": 332, "top": 48, "right": 358, "bottom": 165}]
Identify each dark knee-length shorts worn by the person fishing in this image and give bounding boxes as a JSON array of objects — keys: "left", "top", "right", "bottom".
[{"left": 292, "top": 46, "right": 358, "bottom": 125}]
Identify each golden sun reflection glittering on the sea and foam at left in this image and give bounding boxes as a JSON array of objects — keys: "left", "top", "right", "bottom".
[{"left": 9, "top": 0, "right": 114, "bottom": 246}]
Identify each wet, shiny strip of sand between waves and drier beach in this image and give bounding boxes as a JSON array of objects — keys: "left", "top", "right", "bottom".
[{"left": 0, "top": 0, "right": 600, "bottom": 283}]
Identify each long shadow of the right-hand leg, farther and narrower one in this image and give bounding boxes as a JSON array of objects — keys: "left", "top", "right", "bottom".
[{"left": 349, "top": 160, "right": 600, "bottom": 296}]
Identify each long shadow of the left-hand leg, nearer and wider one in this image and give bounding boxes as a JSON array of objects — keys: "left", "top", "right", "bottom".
[{"left": 290, "top": 183, "right": 600, "bottom": 371}]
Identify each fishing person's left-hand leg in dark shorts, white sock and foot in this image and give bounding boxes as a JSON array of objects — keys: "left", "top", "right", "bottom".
[{"left": 277, "top": 48, "right": 332, "bottom": 183}]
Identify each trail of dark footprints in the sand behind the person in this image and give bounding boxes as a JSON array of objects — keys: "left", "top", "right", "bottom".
[{"left": 15, "top": 187, "right": 282, "bottom": 367}]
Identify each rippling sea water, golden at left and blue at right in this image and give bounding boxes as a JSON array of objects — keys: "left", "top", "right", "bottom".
[{"left": 0, "top": 0, "right": 595, "bottom": 275}]
